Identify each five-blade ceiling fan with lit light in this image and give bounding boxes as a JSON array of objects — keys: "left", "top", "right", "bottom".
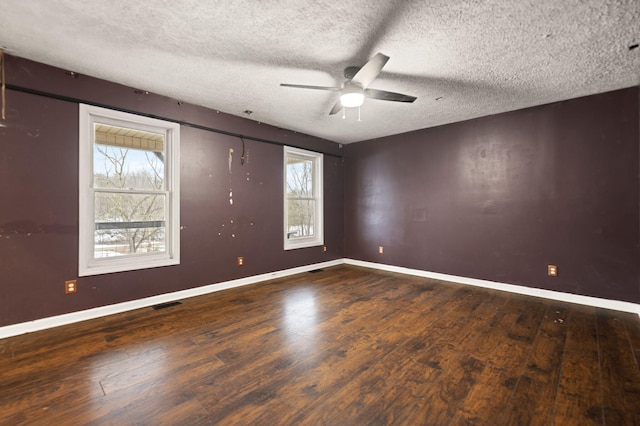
[{"left": 280, "top": 53, "right": 417, "bottom": 115}]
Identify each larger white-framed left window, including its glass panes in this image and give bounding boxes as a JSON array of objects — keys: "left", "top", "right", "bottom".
[{"left": 78, "top": 104, "right": 180, "bottom": 276}]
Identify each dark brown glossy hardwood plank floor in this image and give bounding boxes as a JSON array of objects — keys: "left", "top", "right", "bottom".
[{"left": 0, "top": 266, "right": 640, "bottom": 425}]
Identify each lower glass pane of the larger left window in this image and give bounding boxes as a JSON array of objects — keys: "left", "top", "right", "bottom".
[{"left": 94, "top": 192, "right": 166, "bottom": 258}]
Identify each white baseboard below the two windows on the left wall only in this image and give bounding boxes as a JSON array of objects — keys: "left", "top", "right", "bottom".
[{"left": 0, "top": 259, "right": 344, "bottom": 339}]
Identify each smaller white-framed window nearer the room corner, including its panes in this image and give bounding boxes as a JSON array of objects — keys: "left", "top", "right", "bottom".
[{"left": 284, "top": 146, "right": 324, "bottom": 250}]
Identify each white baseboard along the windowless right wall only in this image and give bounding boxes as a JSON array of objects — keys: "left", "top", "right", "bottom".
[{"left": 344, "top": 259, "right": 640, "bottom": 316}]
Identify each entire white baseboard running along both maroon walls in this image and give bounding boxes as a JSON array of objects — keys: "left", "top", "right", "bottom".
[{"left": 0, "top": 259, "right": 640, "bottom": 339}]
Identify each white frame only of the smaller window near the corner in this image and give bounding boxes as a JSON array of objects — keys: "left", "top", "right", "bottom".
[{"left": 283, "top": 146, "right": 324, "bottom": 250}]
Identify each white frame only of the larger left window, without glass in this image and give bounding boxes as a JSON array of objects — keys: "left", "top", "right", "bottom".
[{"left": 78, "top": 104, "right": 180, "bottom": 276}]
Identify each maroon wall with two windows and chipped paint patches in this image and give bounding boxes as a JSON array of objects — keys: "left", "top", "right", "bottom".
[{"left": 0, "top": 56, "right": 344, "bottom": 326}]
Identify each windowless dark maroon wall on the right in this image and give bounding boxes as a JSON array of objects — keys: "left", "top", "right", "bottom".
[{"left": 345, "top": 87, "right": 640, "bottom": 303}]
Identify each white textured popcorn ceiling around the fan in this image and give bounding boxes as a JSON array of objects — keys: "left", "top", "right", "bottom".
[{"left": 0, "top": 0, "right": 640, "bottom": 143}]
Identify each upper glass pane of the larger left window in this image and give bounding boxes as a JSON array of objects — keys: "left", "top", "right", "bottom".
[{"left": 93, "top": 144, "right": 164, "bottom": 190}]
